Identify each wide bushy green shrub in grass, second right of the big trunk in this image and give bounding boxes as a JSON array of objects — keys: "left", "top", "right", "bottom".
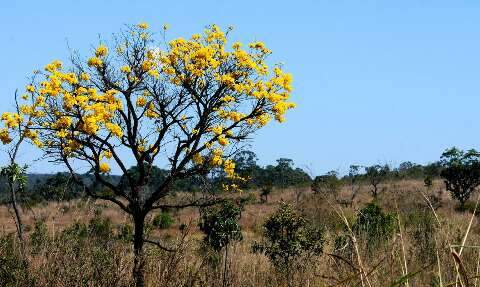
[{"left": 252, "top": 203, "right": 324, "bottom": 286}]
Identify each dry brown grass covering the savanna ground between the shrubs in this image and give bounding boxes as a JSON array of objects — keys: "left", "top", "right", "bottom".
[{"left": 0, "top": 180, "right": 480, "bottom": 287}]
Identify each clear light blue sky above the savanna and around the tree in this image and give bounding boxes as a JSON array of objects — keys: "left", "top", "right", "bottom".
[{"left": 0, "top": 0, "right": 480, "bottom": 174}]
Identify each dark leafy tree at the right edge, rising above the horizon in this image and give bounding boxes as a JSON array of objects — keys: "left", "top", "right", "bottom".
[{"left": 440, "top": 147, "right": 480, "bottom": 209}]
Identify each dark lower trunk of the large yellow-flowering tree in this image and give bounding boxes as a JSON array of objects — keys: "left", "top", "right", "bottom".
[{"left": 133, "top": 215, "right": 145, "bottom": 287}]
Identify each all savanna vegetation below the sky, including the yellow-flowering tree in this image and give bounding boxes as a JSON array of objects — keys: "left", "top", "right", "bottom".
[{"left": 0, "top": 23, "right": 480, "bottom": 287}]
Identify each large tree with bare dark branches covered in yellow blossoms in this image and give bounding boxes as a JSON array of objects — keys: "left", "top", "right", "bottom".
[{"left": 0, "top": 23, "right": 295, "bottom": 286}]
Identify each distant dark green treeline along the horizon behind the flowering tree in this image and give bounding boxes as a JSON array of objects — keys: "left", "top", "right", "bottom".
[{"left": 0, "top": 151, "right": 442, "bottom": 203}]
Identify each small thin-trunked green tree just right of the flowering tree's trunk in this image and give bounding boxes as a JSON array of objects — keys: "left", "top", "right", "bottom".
[{"left": 199, "top": 201, "right": 243, "bottom": 286}]
